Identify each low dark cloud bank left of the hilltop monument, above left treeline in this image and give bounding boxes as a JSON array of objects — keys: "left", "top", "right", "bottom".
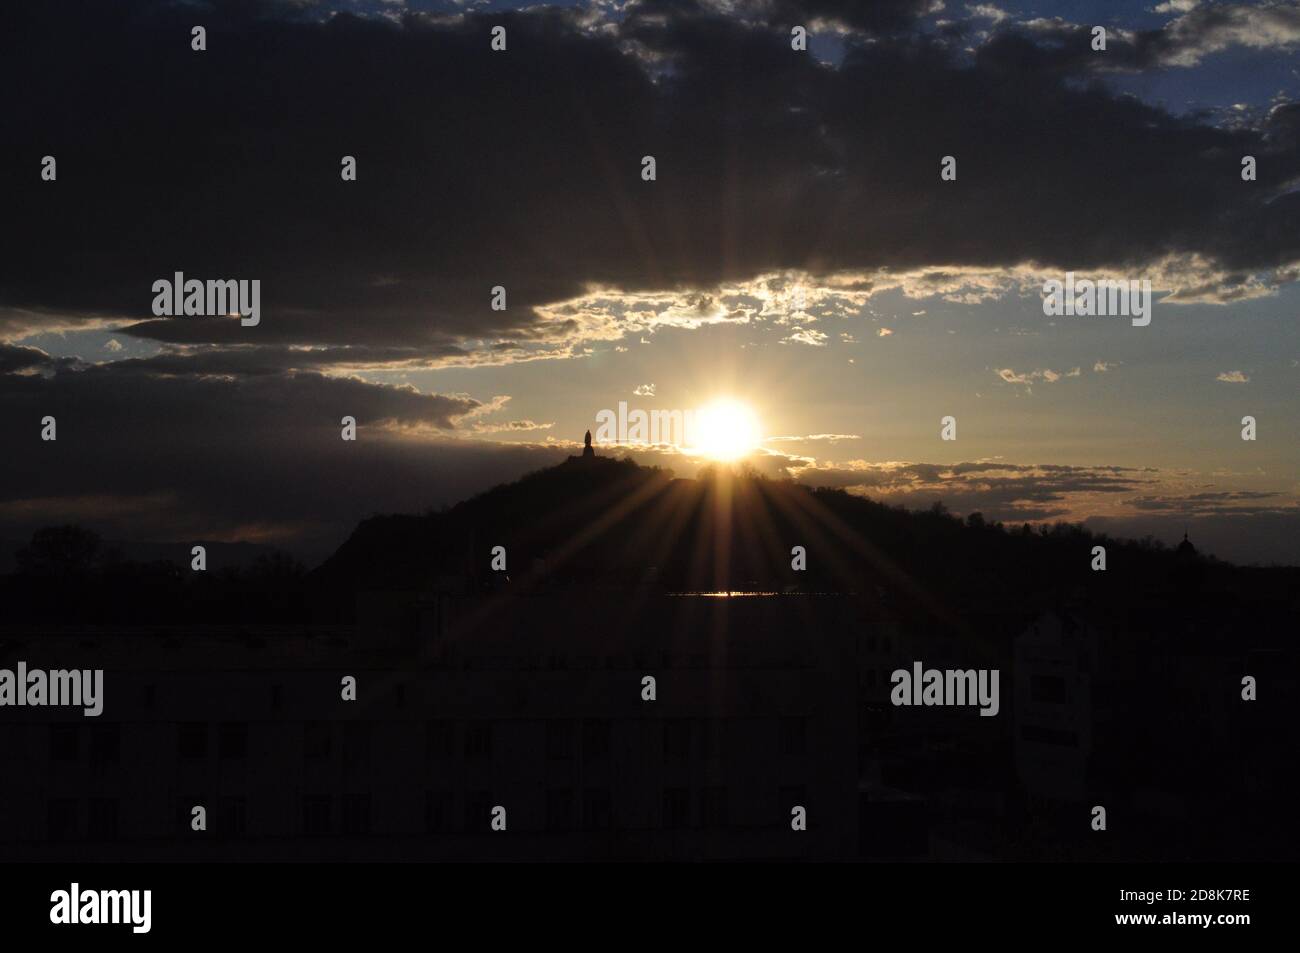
[{"left": 0, "top": 361, "right": 527, "bottom": 555}]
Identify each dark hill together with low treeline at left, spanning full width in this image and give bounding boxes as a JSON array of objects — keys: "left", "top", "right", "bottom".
[{"left": 0, "top": 456, "right": 1300, "bottom": 628}]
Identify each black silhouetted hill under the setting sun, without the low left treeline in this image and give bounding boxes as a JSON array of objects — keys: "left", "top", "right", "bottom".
[{"left": 311, "top": 458, "right": 1300, "bottom": 631}]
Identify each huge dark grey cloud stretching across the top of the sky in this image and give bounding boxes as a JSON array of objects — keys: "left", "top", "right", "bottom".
[{"left": 0, "top": 0, "right": 1300, "bottom": 360}]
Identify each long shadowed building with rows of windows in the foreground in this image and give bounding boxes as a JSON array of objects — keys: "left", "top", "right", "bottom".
[{"left": 0, "top": 592, "right": 873, "bottom": 859}]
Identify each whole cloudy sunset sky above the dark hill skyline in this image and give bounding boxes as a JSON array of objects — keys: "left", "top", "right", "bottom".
[{"left": 0, "top": 0, "right": 1300, "bottom": 564}]
